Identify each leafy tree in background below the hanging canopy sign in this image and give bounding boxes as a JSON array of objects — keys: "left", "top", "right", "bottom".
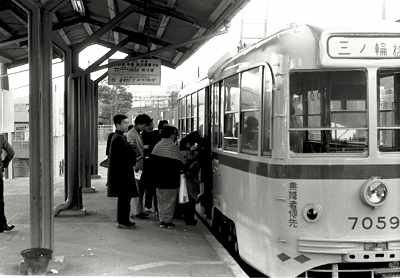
[{"left": 99, "top": 84, "right": 132, "bottom": 124}]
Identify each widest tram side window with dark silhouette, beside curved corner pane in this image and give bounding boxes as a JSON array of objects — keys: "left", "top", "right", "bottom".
[{"left": 239, "top": 66, "right": 263, "bottom": 155}]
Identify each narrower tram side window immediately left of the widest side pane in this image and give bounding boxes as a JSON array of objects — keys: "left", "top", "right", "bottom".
[{"left": 224, "top": 74, "right": 240, "bottom": 151}]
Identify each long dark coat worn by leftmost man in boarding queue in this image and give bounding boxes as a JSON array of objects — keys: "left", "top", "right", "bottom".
[{"left": 108, "top": 130, "right": 137, "bottom": 197}]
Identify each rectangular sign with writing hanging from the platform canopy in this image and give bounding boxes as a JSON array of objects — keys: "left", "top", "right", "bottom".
[{"left": 108, "top": 59, "right": 161, "bottom": 85}]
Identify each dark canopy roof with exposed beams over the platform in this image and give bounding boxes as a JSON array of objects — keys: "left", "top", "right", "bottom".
[{"left": 0, "top": 0, "right": 249, "bottom": 68}]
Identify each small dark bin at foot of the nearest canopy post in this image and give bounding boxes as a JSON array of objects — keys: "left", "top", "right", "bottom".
[{"left": 21, "top": 248, "right": 53, "bottom": 275}]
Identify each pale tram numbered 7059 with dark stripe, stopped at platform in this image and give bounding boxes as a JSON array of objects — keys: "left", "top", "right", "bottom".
[{"left": 178, "top": 22, "right": 400, "bottom": 277}]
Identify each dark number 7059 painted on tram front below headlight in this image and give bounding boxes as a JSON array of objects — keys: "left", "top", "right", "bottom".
[{"left": 347, "top": 216, "right": 400, "bottom": 230}]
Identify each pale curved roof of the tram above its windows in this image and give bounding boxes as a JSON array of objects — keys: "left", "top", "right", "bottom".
[{"left": 207, "top": 21, "right": 400, "bottom": 82}]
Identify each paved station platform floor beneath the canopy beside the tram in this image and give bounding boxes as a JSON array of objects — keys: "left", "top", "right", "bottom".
[{"left": 0, "top": 175, "right": 246, "bottom": 277}]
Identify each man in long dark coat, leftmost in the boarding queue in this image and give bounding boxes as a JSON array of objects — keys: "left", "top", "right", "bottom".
[{"left": 108, "top": 114, "right": 137, "bottom": 229}]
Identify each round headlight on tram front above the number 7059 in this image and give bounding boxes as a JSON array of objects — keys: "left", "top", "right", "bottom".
[{"left": 361, "top": 178, "right": 388, "bottom": 207}]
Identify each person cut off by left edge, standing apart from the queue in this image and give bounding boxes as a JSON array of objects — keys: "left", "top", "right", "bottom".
[{"left": 0, "top": 135, "right": 15, "bottom": 233}]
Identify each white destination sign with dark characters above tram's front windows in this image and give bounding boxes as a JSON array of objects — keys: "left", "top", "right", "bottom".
[{"left": 328, "top": 36, "right": 400, "bottom": 59}]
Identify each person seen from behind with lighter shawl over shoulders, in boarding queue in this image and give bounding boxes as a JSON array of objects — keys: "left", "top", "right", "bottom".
[{"left": 149, "top": 126, "right": 184, "bottom": 228}]
